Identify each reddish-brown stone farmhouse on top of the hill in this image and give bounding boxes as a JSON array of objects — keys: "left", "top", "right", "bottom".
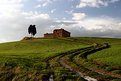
[{"left": 44, "top": 28, "right": 71, "bottom": 38}]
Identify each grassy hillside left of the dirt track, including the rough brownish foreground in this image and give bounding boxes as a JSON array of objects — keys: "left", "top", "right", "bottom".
[{"left": 0, "top": 38, "right": 88, "bottom": 81}]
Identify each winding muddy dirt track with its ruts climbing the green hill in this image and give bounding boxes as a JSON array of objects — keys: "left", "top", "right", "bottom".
[{"left": 46, "top": 45, "right": 120, "bottom": 81}]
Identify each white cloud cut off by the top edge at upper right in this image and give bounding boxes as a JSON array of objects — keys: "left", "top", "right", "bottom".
[{"left": 76, "top": 0, "right": 119, "bottom": 8}]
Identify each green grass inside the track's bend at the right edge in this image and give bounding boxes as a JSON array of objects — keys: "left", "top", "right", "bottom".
[{"left": 79, "top": 38, "right": 121, "bottom": 66}]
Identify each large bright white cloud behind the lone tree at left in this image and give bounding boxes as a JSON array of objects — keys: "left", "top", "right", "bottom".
[{"left": 0, "top": 0, "right": 53, "bottom": 42}]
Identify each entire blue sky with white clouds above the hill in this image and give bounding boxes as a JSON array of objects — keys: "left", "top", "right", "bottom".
[{"left": 0, "top": 0, "right": 121, "bottom": 43}]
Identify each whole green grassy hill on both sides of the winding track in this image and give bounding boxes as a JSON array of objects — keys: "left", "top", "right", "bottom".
[{"left": 0, "top": 37, "right": 121, "bottom": 81}]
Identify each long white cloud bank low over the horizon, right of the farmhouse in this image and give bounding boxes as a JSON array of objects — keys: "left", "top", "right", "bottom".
[{"left": 52, "top": 13, "right": 121, "bottom": 37}]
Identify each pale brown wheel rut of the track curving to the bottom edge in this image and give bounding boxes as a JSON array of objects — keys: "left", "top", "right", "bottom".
[{"left": 59, "top": 47, "right": 98, "bottom": 81}]
